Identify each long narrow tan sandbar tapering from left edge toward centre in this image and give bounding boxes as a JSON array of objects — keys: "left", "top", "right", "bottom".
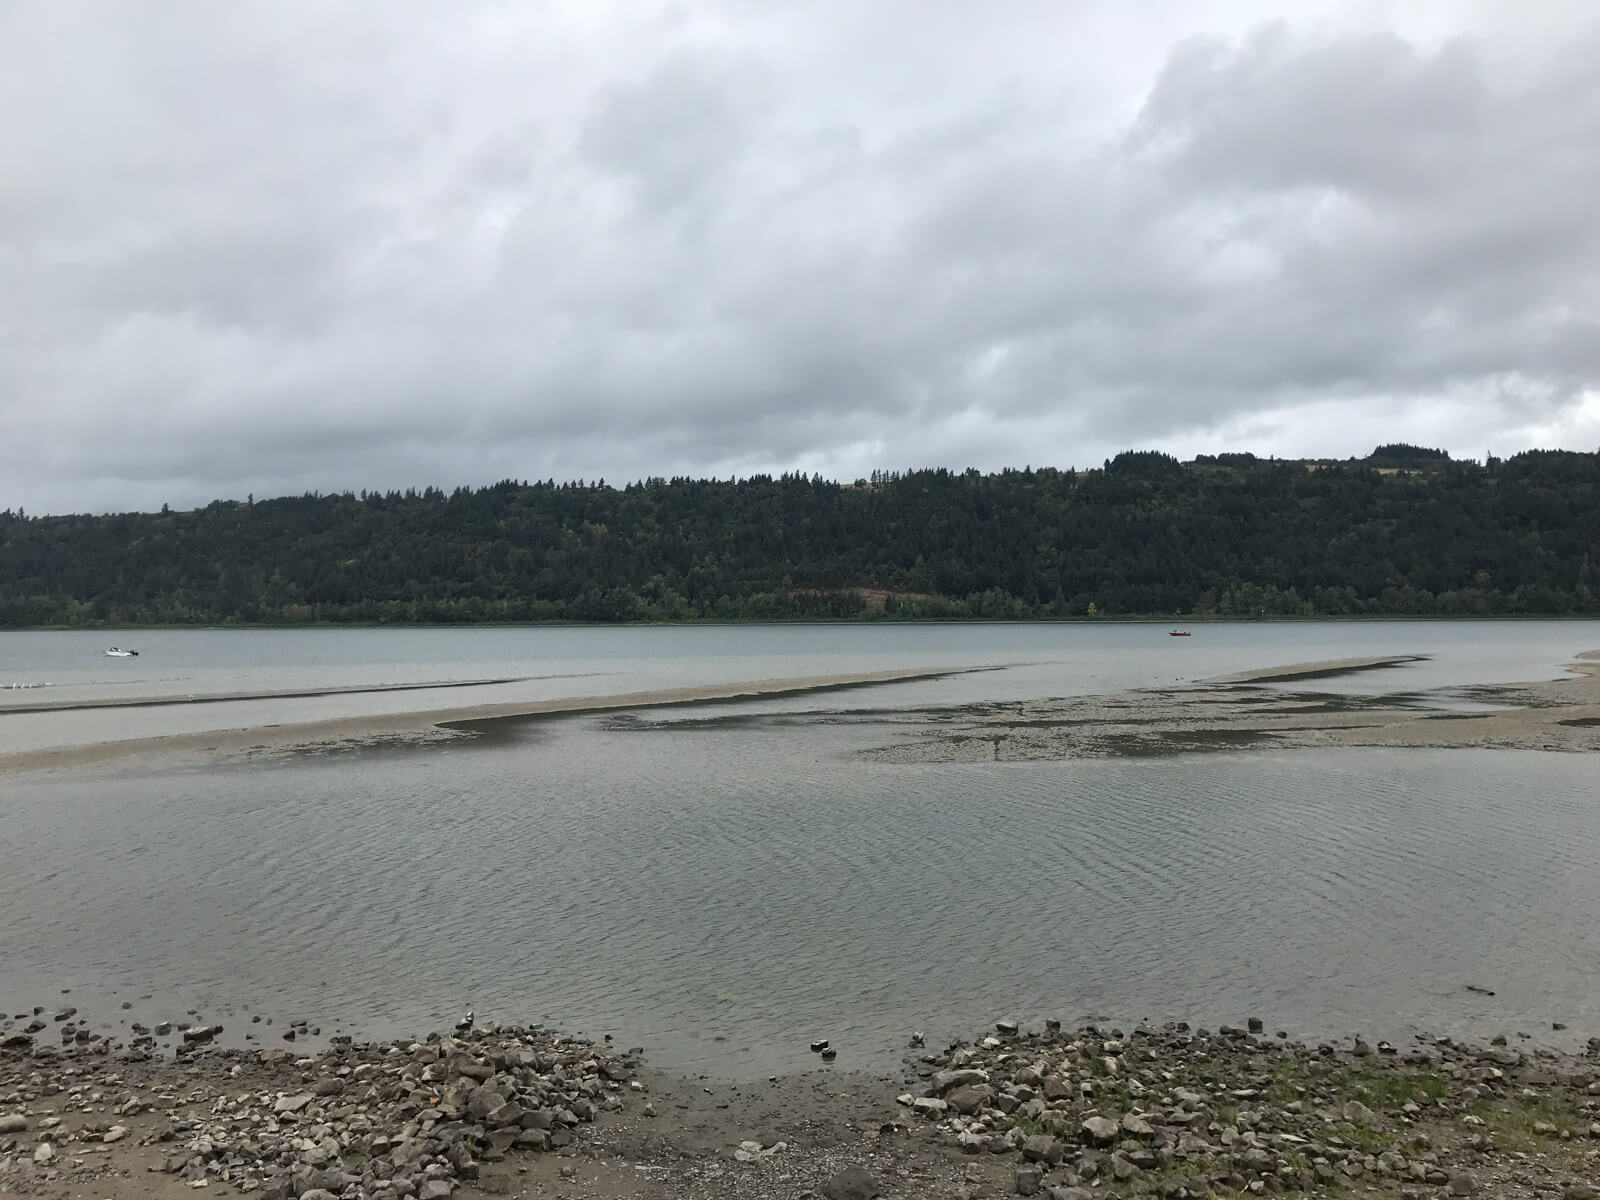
[{"left": 0, "top": 667, "right": 982, "bottom": 774}]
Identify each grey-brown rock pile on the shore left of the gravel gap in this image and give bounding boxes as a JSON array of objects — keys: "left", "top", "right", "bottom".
[{"left": 0, "top": 1026, "right": 640, "bottom": 1200}]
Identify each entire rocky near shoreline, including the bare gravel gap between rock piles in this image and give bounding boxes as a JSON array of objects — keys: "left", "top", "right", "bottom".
[{"left": 0, "top": 1021, "right": 1600, "bottom": 1200}]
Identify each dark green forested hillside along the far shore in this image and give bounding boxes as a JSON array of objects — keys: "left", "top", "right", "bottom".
[{"left": 0, "top": 446, "right": 1600, "bottom": 627}]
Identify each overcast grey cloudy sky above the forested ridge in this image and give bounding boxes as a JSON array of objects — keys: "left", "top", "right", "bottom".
[{"left": 0, "top": 0, "right": 1600, "bottom": 512}]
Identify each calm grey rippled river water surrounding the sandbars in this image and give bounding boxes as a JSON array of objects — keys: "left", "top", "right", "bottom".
[{"left": 0, "top": 622, "right": 1600, "bottom": 1075}]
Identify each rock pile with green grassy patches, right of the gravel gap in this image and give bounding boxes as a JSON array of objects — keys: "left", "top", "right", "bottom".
[{"left": 901, "top": 1021, "right": 1600, "bottom": 1200}]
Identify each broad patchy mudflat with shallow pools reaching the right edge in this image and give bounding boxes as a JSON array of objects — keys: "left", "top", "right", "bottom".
[{"left": 864, "top": 653, "right": 1600, "bottom": 763}]
